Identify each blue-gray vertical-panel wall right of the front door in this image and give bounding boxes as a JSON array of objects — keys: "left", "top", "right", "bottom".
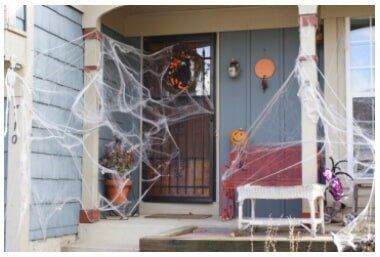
[{"left": 219, "top": 28, "right": 301, "bottom": 217}]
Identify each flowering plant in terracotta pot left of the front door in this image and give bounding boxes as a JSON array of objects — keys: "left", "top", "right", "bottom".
[{"left": 102, "top": 138, "right": 133, "bottom": 205}]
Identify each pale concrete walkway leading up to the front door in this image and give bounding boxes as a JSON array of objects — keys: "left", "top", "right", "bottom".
[{"left": 62, "top": 216, "right": 237, "bottom": 251}]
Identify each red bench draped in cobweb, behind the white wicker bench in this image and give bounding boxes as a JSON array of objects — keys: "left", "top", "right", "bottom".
[{"left": 221, "top": 146, "right": 302, "bottom": 220}]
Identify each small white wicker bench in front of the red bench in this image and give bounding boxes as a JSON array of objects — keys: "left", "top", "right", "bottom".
[{"left": 237, "top": 184, "right": 325, "bottom": 236}]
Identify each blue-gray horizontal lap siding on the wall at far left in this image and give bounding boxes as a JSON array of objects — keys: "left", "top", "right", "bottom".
[{"left": 30, "top": 6, "right": 83, "bottom": 240}]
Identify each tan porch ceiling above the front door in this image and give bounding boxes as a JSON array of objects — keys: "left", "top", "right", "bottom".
[{"left": 102, "top": 5, "right": 298, "bottom": 36}]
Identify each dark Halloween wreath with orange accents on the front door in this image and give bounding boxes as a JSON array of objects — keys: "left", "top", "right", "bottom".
[{"left": 164, "top": 48, "right": 203, "bottom": 94}]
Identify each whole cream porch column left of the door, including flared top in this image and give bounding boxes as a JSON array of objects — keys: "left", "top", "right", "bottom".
[{"left": 75, "top": 5, "right": 118, "bottom": 223}]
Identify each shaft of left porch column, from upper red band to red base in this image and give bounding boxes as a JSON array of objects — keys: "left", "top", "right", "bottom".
[{"left": 80, "top": 28, "right": 101, "bottom": 223}]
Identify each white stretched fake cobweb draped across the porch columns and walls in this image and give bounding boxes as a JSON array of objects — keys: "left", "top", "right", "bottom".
[{"left": 5, "top": 28, "right": 375, "bottom": 250}]
